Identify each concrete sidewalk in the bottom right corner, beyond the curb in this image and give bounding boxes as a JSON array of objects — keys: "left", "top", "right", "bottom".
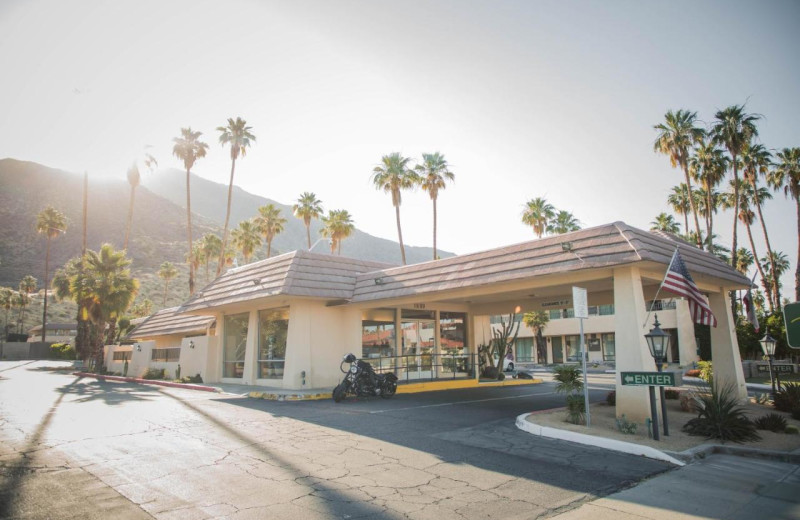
[{"left": 551, "top": 455, "right": 800, "bottom": 520}]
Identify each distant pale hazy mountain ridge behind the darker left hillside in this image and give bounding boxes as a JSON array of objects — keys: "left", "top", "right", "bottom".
[{"left": 142, "top": 169, "right": 446, "bottom": 265}]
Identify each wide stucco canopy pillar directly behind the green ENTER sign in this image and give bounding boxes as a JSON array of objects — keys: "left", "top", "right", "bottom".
[{"left": 614, "top": 267, "right": 656, "bottom": 423}]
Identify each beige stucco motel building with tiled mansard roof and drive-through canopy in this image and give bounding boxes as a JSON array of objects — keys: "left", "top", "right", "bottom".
[{"left": 117, "top": 222, "right": 750, "bottom": 421}]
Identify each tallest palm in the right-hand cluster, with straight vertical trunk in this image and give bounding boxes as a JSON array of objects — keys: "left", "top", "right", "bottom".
[{"left": 711, "top": 105, "right": 761, "bottom": 272}]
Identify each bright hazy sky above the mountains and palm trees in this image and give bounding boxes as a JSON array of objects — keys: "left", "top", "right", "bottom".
[{"left": 0, "top": 0, "right": 800, "bottom": 295}]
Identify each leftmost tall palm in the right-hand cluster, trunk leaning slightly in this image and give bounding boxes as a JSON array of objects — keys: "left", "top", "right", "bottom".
[{"left": 653, "top": 110, "right": 705, "bottom": 249}]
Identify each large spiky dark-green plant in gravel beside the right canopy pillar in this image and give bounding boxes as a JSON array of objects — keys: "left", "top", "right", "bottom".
[{"left": 683, "top": 385, "right": 761, "bottom": 442}]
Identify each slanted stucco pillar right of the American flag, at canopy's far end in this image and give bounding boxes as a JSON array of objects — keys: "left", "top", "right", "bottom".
[{"left": 708, "top": 290, "right": 747, "bottom": 400}]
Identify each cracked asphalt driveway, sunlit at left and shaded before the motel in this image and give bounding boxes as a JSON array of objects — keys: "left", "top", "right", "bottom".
[{"left": 0, "top": 362, "right": 670, "bottom": 520}]
